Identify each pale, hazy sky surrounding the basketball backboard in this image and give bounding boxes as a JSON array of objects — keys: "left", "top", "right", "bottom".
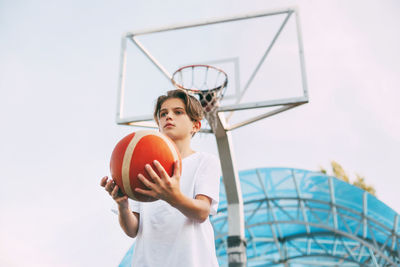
[{"left": 0, "top": 0, "right": 400, "bottom": 266}]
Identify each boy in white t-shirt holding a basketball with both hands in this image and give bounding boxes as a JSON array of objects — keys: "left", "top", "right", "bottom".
[{"left": 101, "top": 90, "right": 220, "bottom": 267}]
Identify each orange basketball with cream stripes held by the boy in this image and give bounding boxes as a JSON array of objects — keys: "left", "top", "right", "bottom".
[{"left": 110, "top": 131, "right": 182, "bottom": 202}]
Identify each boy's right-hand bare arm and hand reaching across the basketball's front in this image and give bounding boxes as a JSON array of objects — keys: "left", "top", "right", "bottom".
[{"left": 135, "top": 161, "right": 211, "bottom": 222}]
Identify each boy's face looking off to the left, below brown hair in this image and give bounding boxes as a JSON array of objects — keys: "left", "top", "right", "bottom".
[{"left": 158, "top": 98, "right": 200, "bottom": 141}]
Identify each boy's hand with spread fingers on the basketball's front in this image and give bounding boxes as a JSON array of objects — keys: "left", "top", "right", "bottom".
[{"left": 135, "top": 160, "right": 181, "bottom": 205}]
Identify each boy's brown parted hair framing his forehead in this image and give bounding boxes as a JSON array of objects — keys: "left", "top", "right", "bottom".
[{"left": 153, "top": 89, "right": 204, "bottom": 125}]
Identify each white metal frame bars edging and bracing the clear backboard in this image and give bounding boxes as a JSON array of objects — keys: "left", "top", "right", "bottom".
[{"left": 116, "top": 7, "right": 308, "bottom": 133}]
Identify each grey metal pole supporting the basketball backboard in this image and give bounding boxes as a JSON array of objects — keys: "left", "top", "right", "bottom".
[{"left": 210, "top": 113, "right": 247, "bottom": 267}]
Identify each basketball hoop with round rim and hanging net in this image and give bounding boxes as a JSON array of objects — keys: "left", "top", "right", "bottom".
[{"left": 171, "top": 65, "right": 228, "bottom": 130}]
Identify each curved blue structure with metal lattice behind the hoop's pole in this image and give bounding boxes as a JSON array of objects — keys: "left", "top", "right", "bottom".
[{"left": 120, "top": 168, "right": 400, "bottom": 267}]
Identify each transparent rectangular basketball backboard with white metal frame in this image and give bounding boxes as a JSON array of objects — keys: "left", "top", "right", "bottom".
[{"left": 116, "top": 8, "right": 308, "bottom": 132}]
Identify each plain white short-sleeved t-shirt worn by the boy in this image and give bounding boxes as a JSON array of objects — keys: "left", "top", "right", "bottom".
[{"left": 131, "top": 152, "right": 221, "bottom": 267}]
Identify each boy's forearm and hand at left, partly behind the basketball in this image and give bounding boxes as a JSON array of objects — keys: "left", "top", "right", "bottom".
[{"left": 100, "top": 176, "right": 140, "bottom": 238}]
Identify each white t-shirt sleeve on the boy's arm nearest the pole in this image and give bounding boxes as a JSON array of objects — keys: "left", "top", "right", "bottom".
[{"left": 194, "top": 154, "right": 221, "bottom": 215}]
